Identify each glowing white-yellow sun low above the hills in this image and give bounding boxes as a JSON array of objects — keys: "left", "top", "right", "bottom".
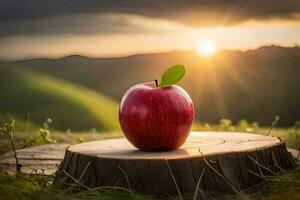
[{"left": 196, "top": 39, "right": 218, "bottom": 57}]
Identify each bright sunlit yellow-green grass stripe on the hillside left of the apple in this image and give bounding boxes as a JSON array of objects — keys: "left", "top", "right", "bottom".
[{"left": 24, "top": 71, "right": 119, "bottom": 130}]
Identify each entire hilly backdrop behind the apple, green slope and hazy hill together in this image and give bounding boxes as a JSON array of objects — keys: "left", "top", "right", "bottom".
[{"left": 0, "top": 46, "right": 300, "bottom": 132}]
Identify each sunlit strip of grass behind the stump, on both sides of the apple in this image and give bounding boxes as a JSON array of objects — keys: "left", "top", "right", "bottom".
[{"left": 0, "top": 119, "right": 300, "bottom": 154}]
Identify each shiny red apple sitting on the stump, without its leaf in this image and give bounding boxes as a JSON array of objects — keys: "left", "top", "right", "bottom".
[{"left": 119, "top": 83, "right": 194, "bottom": 151}]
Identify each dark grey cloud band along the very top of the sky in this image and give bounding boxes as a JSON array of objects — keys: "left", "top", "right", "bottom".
[{"left": 0, "top": 0, "right": 300, "bottom": 23}]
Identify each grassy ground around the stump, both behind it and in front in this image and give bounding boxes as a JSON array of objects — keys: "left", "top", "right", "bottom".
[{"left": 0, "top": 120, "right": 300, "bottom": 200}]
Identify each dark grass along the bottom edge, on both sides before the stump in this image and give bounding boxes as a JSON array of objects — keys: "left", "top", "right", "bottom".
[{"left": 0, "top": 147, "right": 300, "bottom": 200}]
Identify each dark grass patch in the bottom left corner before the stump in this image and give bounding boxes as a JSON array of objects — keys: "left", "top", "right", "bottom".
[{"left": 0, "top": 174, "right": 152, "bottom": 200}]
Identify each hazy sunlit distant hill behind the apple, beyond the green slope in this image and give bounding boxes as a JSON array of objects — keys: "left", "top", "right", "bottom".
[{"left": 14, "top": 46, "right": 300, "bottom": 126}]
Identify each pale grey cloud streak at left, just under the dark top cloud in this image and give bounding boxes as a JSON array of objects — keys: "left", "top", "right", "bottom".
[{"left": 0, "top": 14, "right": 150, "bottom": 36}]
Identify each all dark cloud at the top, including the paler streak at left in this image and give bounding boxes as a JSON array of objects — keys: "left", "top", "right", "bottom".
[{"left": 0, "top": 0, "right": 300, "bottom": 35}]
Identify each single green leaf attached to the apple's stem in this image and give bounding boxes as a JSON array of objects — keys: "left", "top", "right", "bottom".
[{"left": 159, "top": 65, "right": 185, "bottom": 87}]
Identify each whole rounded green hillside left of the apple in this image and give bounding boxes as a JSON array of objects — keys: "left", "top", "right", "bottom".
[{"left": 0, "top": 62, "right": 119, "bottom": 130}]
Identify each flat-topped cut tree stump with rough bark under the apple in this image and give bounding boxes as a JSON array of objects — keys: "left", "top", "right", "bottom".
[{"left": 55, "top": 132, "right": 296, "bottom": 195}]
